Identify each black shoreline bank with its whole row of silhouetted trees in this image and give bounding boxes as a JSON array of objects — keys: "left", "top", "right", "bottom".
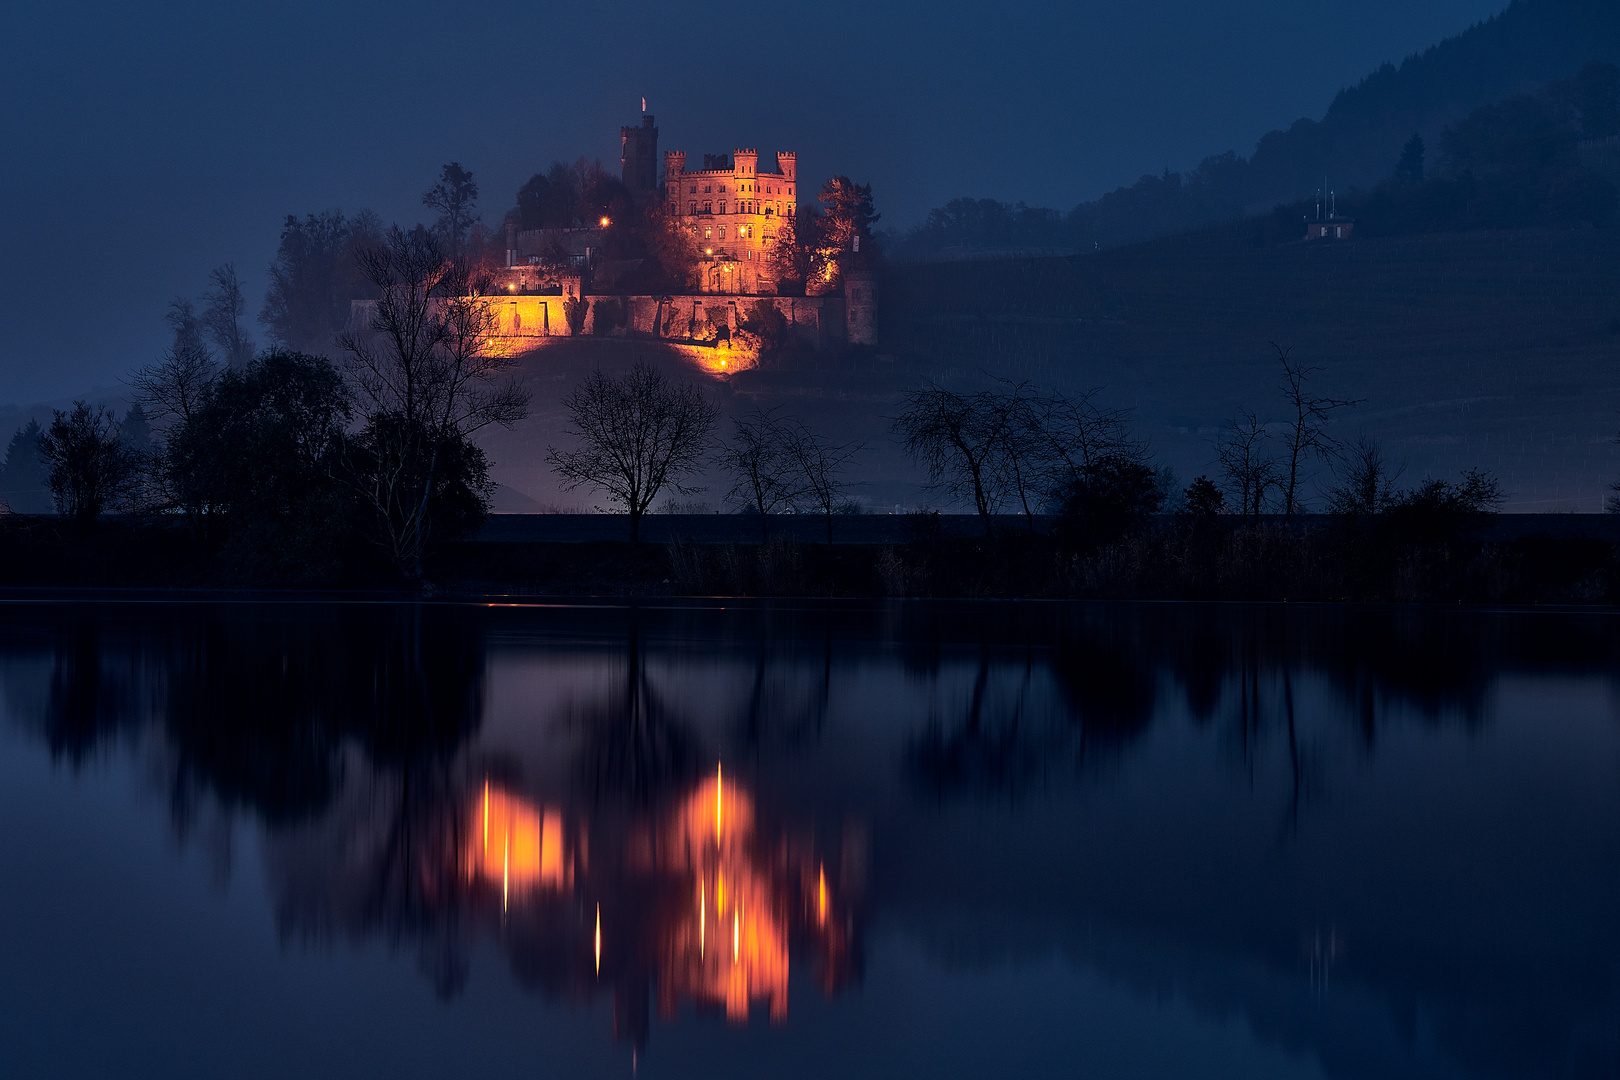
[{"left": 0, "top": 330, "right": 1600, "bottom": 602}]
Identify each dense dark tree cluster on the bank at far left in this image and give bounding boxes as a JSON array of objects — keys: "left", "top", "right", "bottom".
[{"left": 5, "top": 227, "right": 528, "bottom": 585}]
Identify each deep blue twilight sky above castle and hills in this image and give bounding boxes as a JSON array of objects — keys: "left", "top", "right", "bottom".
[{"left": 0, "top": 0, "right": 1505, "bottom": 405}]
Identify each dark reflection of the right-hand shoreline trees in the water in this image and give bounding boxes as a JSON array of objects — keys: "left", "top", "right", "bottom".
[{"left": 902, "top": 604, "right": 1587, "bottom": 816}]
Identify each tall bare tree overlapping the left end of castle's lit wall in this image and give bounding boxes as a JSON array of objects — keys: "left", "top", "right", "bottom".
[{"left": 339, "top": 227, "right": 528, "bottom": 580}]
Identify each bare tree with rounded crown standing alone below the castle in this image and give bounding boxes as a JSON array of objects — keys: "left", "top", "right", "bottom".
[{"left": 546, "top": 363, "right": 716, "bottom": 542}]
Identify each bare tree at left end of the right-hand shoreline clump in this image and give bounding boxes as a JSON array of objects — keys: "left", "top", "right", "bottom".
[{"left": 894, "top": 382, "right": 1013, "bottom": 536}]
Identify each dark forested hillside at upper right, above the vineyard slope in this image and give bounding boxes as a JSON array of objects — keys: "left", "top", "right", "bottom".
[{"left": 891, "top": 0, "right": 1620, "bottom": 259}]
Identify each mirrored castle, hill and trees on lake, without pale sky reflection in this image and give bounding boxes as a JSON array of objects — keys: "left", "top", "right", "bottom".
[{"left": 0, "top": 604, "right": 1620, "bottom": 1077}]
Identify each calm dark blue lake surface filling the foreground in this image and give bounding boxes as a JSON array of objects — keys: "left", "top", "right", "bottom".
[{"left": 0, "top": 602, "right": 1620, "bottom": 1080}]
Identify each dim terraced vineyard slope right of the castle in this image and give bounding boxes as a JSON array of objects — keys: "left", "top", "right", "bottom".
[{"left": 885, "top": 230, "right": 1620, "bottom": 512}]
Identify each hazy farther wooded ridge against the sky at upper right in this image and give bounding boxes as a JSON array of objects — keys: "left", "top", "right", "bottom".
[{"left": 891, "top": 0, "right": 1620, "bottom": 259}]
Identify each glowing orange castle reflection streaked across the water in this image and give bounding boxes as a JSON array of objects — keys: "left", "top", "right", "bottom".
[{"left": 463, "top": 766, "right": 859, "bottom": 1044}]
